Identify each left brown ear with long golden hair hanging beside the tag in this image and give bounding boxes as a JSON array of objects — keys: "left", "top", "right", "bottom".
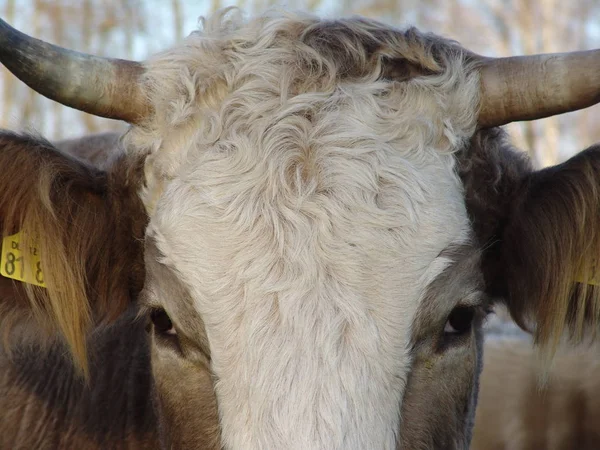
[{"left": 0, "top": 132, "right": 146, "bottom": 372}]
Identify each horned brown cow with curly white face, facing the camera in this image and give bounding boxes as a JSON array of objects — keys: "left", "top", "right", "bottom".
[{"left": 0, "top": 10, "right": 600, "bottom": 450}]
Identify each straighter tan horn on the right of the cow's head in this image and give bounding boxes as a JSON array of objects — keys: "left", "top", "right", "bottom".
[{"left": 478, "top": 50, "right": 600, "bottom": 128}]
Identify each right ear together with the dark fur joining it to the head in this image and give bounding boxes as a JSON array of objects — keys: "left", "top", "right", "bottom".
[{"left": 460, "top": 130, "right": 600, "bottom": 351}]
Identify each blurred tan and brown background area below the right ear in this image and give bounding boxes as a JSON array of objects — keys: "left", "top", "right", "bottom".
[{"left": 471, "top": 312, "right": 600, "bottom": 450}]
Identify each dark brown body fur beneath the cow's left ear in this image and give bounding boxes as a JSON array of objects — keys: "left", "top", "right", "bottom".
[{"left": 0, "top": 310, "right": 159, "bottom": 450}]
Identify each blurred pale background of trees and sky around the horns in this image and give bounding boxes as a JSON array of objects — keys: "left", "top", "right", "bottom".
[{"left": 0, "top": 0, "right": 600, "bottom": 167}]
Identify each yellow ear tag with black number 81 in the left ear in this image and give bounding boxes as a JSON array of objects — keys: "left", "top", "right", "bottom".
[{"left": 0, "top": 232, "right": 46, "bottom": 287}]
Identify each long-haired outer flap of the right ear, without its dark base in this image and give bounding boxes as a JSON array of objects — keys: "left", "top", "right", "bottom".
[{"left": 503, "top": 146, "right": 600, "bottom": 349}]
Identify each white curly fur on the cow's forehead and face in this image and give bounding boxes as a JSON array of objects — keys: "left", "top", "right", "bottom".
[{"left": 126, "top": 11, "right": 479, "bottom": 450}]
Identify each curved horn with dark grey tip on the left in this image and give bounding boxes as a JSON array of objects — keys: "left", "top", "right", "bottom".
[{"left": 0, "top": 19, "right": 150, "bottom": 123}]
